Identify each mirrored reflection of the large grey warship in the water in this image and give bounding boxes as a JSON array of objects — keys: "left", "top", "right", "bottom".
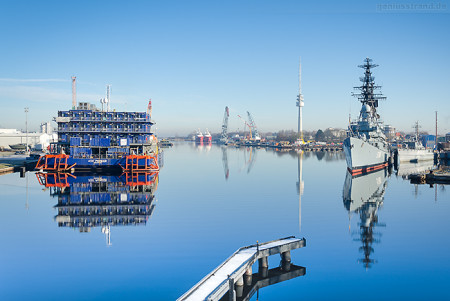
[{"left": 343, "top": 169, "right": 388, "bottom": 269}]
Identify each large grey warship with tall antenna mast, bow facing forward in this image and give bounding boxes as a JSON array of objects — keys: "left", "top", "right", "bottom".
[{"left": 344, "top": 58, "right": 389, "bottom": 175}]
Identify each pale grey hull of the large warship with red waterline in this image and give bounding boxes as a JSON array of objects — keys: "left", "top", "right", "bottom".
[{"left": 344, "top": 137, "right": 389, "bottom": 175}]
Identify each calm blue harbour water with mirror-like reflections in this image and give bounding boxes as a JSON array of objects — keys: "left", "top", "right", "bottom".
[{"left": 0, "top": 143, "right": 450, "bottom": 300}]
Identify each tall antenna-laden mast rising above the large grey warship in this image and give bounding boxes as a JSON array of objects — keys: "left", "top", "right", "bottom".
[{"left": 352, "top": 58, "right": 386, "bottom": 118}]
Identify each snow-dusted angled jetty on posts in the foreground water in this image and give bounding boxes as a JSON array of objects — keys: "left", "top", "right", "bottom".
[{"left": 177, "top": 236, "right": 306, "bottom": 301}]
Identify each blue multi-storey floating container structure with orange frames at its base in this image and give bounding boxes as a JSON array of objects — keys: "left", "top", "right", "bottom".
[{"left": 36, "top": 103, "right": 159, "bottom": 171}]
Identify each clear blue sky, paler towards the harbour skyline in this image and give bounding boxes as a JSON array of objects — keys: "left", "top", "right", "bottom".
[{"left": 0, "top": 0, "right": 450, "bottom": 135}]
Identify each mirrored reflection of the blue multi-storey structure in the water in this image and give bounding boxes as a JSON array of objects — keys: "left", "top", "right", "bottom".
[{"left": 36, "top": 172, "right": 158, "bottom": 246}]
